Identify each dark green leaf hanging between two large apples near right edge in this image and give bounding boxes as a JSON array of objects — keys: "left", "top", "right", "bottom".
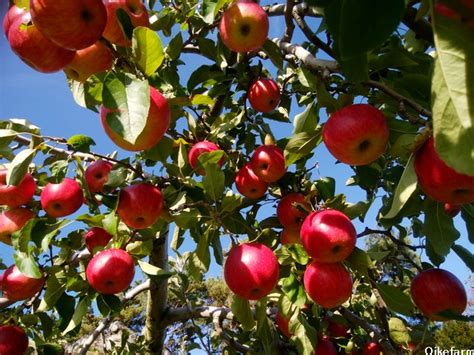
[{"left": 423, "top": 198, "right": 459, "bottom": 256}]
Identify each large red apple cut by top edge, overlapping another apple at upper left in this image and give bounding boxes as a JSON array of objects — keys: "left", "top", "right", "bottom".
[{"left": 30, "top": 0, "right": 107, "bottom": 50}]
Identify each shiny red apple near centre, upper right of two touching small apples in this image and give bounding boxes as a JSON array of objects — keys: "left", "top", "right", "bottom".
[{"left": 250, "top": 144, "right": 286, "bottom": 183}]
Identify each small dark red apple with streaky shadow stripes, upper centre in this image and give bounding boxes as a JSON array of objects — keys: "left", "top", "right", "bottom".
[{"left": 248, "top": 78, "right": 281, "bottom": 112}]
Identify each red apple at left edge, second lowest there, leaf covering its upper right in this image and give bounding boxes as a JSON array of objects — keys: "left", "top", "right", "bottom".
[{"left": 2, "top": 265, "right": 45, "bottom": 301}]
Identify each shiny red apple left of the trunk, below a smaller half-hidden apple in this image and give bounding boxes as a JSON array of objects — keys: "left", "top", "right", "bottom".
[{"left": 86, "top": 249, "right": 135, "bottom": 295}]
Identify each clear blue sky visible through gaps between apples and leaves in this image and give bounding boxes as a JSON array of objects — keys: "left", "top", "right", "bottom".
[{"left": 0, "top": 1, "right": 472, "bottom": 304}]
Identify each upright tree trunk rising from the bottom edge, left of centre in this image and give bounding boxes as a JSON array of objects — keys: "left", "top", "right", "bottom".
[{"left": 145, "top": 226, "right": 169, "bottom": 354}]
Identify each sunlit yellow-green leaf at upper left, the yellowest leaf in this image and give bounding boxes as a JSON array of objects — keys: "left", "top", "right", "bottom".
[{"left": 132, "top": 27, "right": 165, "bottom": 76}]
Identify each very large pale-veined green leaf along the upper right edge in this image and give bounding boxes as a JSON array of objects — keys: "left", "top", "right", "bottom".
[{"left": 432, "top": 11, "right": 474, "bottom": 175}]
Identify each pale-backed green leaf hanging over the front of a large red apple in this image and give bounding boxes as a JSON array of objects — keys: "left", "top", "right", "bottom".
[{"left": 102, "top": 73, "right": 150, "bottom": 144}]
